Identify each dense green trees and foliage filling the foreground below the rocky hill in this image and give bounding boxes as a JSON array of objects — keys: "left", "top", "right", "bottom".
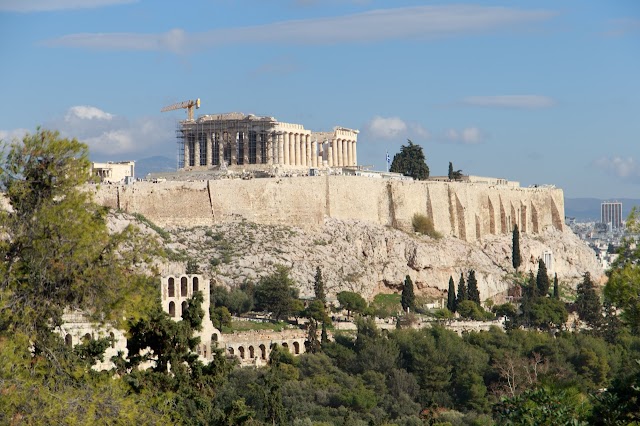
[{"left": 0, "top": 131, "right": 640, "bottom": 425}]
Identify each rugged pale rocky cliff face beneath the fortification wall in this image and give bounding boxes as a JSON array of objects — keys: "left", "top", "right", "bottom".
[{"left": 149, "top": 215, "right": 602, "bottom": 300}]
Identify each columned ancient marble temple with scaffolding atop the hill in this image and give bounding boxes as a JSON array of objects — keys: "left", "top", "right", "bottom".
[{"left": 177, "top": 112, "right": 358, "bottom": 170}]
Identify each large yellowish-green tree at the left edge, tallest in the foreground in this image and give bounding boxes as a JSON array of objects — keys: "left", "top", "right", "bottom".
[{"left": 0, "top": 125, "right": 159, "bottom": 336}]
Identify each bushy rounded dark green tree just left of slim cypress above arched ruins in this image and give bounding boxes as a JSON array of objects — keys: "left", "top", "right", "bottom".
[{"left": 254, "top": 265, "right": 298, "bottom": 319}]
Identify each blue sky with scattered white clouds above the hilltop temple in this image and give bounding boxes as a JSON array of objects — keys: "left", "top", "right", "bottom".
[{"left": 0, "top": 0, "right": 640, "bottom": 199}]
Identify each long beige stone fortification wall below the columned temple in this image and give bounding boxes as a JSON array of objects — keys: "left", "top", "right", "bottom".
[{"left": 92, "top": 176, "right": 564, "bottom": 241}]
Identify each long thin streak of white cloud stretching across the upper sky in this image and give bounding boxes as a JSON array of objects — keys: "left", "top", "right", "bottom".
[{"left": 45, "top": 5, "right": 556, "bottom": 53}]
